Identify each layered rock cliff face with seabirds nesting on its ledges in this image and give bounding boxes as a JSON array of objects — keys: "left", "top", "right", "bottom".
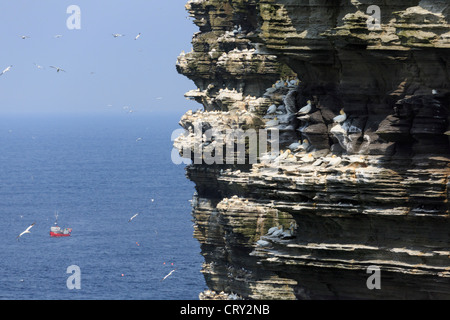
[{"left": 175, "top": 0, "right": 450, "bottom": 299}]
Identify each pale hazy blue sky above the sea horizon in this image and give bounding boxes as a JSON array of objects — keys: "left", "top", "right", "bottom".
[{"left": 0, "top": 0, "right": 199, "bottom": 113}]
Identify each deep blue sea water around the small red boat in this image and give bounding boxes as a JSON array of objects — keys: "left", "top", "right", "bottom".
[{"left": 0, "top": 113, "right": 206, "bottom": 300}]
